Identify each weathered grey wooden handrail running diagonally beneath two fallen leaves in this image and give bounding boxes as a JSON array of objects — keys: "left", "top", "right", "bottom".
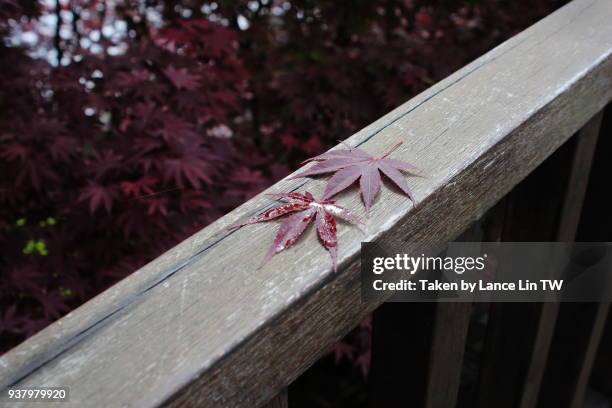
[{"left": 0, "top": 0, "right": 612, "bottom": 407}]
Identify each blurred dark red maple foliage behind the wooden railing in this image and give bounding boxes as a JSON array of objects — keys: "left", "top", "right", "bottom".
[{"left": 0, "top": 0, "right": 565, "bottom": 406}]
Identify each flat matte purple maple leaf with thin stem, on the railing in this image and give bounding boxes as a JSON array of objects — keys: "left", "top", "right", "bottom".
[{"left": 290, "top": 142, "right": 420, "bottom": 211}]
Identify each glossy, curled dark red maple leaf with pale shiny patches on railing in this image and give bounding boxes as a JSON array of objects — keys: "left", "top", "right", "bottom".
[{"left": 230, "top": 192, "right": 361, "bottom": 271}]
